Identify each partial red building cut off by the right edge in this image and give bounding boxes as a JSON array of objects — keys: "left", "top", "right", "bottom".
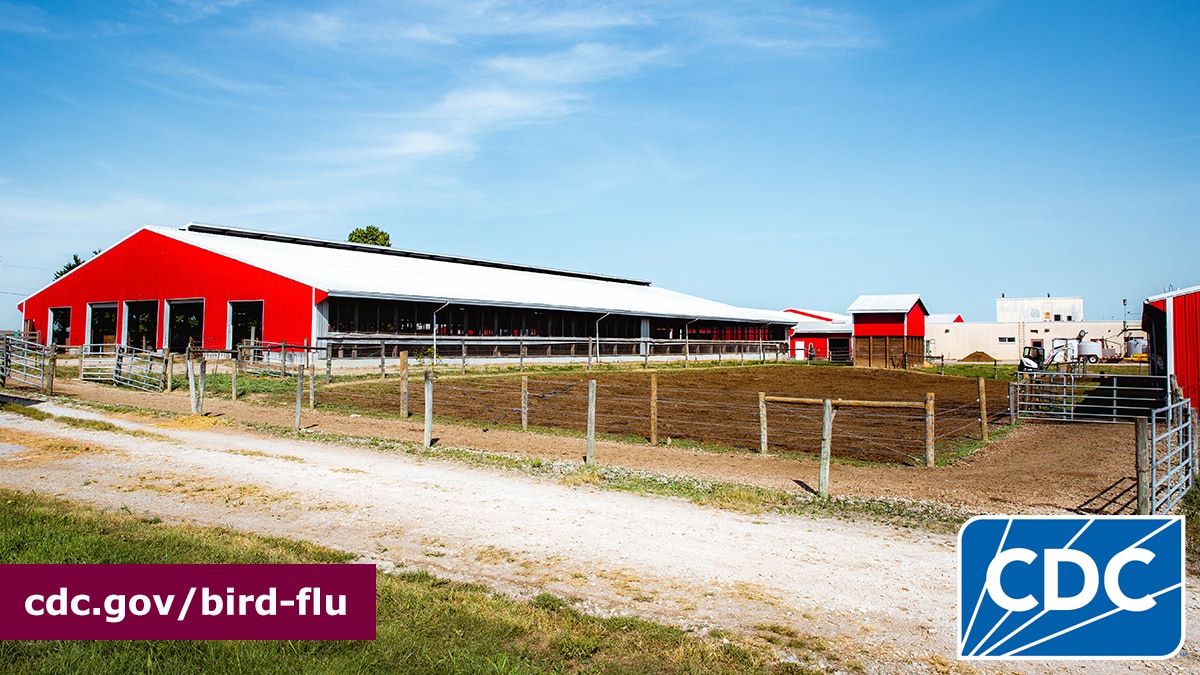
[{"left": 1141, "top": 286, "right": 1200, "bottom": 407}]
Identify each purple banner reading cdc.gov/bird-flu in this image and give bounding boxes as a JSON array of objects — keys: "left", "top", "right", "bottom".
[{"left": 0, "top": 565, "right": 376, "bottom": 640}]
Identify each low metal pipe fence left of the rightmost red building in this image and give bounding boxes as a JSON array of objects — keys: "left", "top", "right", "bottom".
[{"left": 1012, "top": 371, "right": 1168, "bottom": 423}]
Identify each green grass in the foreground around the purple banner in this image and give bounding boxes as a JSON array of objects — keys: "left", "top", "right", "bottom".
[{"left": 0, "top": 490, "right": 829, "bottom": 674}]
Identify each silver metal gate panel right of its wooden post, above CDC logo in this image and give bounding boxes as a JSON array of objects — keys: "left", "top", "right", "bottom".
[{"left": 1148, "top": 399, "right": 1195, "bottom": 514}]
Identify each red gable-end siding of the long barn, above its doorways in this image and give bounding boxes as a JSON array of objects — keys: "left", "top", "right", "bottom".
[{"left": 22, "top": 229, "right": 325, "bottom": 350}]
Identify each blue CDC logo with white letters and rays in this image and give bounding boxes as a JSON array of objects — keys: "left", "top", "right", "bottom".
[{"left": 959, "top": 516, "right": 1186, "bottom": 659}]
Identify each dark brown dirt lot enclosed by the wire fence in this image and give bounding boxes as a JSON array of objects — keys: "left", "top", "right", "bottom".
[{"left": 318, "top": 365, "right": 1008, "bottom": 464}]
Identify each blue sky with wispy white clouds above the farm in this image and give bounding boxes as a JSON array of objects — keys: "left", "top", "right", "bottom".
[{"left": 0, "top": 0, "right": 1200, "bottom": 328}]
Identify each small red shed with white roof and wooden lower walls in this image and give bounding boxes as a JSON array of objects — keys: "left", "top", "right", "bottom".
[{"left": 846, "top": 293, "right": 929, "bottom": 368}]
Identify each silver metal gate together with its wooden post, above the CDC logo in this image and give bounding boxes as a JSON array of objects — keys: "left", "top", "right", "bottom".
[{"left": 1136, "top": 399, "right": 1196, "bottom": 514}]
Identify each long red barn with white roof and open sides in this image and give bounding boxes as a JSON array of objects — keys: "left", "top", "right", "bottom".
[{"left": 18, "top": 223, "right": 794, "bottom": 353}]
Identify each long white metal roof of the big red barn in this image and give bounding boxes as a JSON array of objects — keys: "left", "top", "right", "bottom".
[{"left": 146, "top": 227, "right": 794, "bottom": 324}]
